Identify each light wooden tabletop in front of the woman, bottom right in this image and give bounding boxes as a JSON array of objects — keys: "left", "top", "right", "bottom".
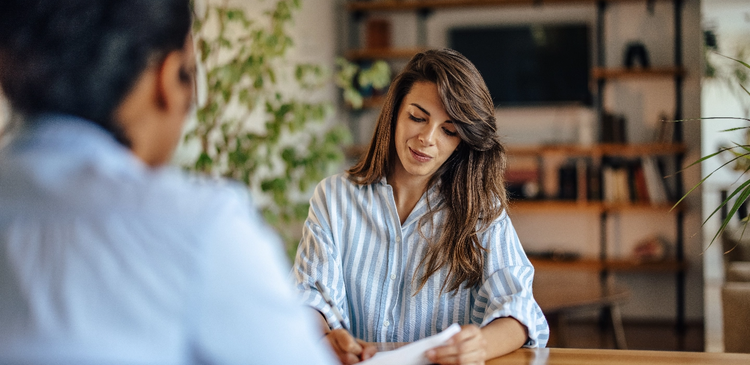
[{"left": 486, "top": 348, "right": 750, "bottom": 365}]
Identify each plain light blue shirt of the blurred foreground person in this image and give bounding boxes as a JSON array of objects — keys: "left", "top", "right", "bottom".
[{"left": 0, "top": 116, "right": 333, "bottom": 364}]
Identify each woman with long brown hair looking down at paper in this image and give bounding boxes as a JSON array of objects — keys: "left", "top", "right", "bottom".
[{"left": 294, "top": 49, "right": 549, "bottom": 364}]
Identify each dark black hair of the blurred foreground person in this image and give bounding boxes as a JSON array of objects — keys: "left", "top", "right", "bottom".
[{"left": 0, "top": 0, "right": 192, "bottom": 145}]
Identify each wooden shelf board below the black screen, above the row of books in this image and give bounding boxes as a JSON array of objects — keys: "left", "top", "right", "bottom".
[{"left": 508, "top": 143, "right": 685, "bottom": 157}]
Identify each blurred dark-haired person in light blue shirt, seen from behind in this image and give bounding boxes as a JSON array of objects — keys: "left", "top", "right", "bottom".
[{"left": 0, "top": 0, "right": 333, "bottom": 364}]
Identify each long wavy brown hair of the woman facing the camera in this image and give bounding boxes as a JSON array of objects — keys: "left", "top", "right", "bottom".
[{"left": 348, "top": 49, "right": 508, "bottom": 292}]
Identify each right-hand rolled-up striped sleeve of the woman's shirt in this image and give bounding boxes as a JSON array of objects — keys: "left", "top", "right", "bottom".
[{"left": 472, "top": 214, "right": 549, "bottom": 347}]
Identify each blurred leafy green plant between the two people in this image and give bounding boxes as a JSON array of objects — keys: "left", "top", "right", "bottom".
[{"left": 181, "top": 0, "right": 348, "bottom": 252}]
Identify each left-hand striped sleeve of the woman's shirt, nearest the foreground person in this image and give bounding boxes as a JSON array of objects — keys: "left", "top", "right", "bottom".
[{"left": 292, "top": 181, "right": 350, "bottom": 328}]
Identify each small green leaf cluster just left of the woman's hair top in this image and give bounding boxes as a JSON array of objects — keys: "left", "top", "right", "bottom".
[{"left": 334, "top": 57, "right": 391, "bottom": 110}]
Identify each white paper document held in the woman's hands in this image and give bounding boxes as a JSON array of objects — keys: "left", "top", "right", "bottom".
[{"left": 360, "top": 323, "right": 461, "bottom": 365}]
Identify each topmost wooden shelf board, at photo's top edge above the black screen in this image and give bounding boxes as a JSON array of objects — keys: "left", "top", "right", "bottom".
[{"left": 346, "top": 0, "right": 668, "bottom": 12}]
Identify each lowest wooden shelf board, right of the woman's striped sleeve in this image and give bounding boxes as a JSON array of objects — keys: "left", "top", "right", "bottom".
[{"left": 529, "top": 257, "right": 687, "bottom": 273}]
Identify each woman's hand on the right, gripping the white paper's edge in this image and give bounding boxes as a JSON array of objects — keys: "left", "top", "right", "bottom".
[{"left": 426, "top": 324, "right": 487, "bottom": 365}]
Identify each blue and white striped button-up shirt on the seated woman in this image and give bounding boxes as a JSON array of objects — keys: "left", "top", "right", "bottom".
[{"left": 294, "top": 174, "right": 549, "bottom": 347}]
